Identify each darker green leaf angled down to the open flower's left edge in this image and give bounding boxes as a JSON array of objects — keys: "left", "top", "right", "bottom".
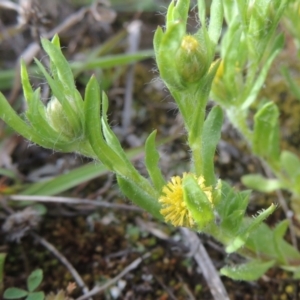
[{"left": 117, "top": 176, "right": 163, "bottom": 220}]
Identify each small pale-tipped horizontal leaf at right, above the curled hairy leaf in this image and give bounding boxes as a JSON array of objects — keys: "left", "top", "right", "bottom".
[{"left": 242, "top": 174, "right": 282, "bottom": 193}]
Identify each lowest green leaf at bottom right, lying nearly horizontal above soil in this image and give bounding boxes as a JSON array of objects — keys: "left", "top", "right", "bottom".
[{"left": 220, "top": 260, "right": 275, "bottom": 281}]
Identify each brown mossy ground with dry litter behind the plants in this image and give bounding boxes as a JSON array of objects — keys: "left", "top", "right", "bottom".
[{"left": 0, "top": 0, "right": 300, "bottom": 300}]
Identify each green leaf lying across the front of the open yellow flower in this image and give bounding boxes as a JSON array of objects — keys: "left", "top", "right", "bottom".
[{"left": 182, "top": 175, "right": 215, "bottom": 231}]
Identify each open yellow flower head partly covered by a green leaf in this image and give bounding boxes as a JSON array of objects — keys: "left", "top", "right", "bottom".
[{"left": 158, "top": 173, "right": 212, "bottom": 227}]
